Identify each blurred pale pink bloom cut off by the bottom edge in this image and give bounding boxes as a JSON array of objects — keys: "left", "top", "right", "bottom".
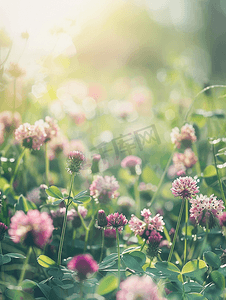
[{"left": 116, "top": 275, "right": 164, "bottom": 300}]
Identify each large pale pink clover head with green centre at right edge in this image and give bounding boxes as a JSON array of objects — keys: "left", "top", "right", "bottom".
[{"left": 190, "top": 194, "right": 225, "bottom": 228}]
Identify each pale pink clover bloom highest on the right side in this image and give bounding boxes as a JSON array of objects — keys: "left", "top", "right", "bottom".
[{"left": 170, "top": 123, "right": 197, "bottom": 149}]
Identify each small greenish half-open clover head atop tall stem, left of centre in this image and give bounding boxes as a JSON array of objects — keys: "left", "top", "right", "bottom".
[{"left": 67, "top": 151, "right": 85, "bottom": 175}]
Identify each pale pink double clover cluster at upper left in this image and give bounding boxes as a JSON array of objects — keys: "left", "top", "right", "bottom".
[{"left": 15, "top": 116, "right": 59, "bottom": 150}]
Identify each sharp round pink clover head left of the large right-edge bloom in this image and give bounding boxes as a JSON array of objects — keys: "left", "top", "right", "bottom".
[{"left": 171, "top": 176, "right": 199, "bottom": 199}]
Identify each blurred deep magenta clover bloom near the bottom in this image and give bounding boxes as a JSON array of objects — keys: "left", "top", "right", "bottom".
[{"left": 67, "top": 254, "right": 99, "bottom": 281}]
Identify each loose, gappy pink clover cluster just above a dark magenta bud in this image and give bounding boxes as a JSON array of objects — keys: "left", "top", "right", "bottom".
[{"left": 129, "top": 208, "right": 165, "bottom": 244}]
